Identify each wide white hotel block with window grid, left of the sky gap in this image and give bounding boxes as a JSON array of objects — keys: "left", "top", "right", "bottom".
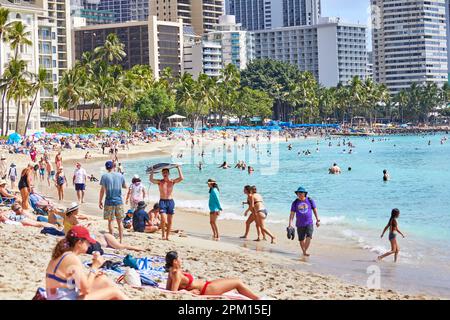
[{"left": 254, "top": 18, "right": 367, "bottom": 87}]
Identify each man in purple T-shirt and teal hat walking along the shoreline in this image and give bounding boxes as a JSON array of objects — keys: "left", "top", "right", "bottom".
[{"left": 289, "top": 187, "right": 320, "bottom": 257}]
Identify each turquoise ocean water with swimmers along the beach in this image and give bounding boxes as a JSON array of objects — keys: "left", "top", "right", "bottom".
[{"left": 119, "top": 134, "right": 450, "bottom": 296}]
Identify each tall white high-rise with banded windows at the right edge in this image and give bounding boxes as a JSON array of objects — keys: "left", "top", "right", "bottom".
[{"left": 372, "top": 0, "right": 448, "bottom": 94}]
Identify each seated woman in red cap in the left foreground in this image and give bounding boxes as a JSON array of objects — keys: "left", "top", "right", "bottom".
[{"left": 45, "top": 226, "right": 128, "bottom": 300}]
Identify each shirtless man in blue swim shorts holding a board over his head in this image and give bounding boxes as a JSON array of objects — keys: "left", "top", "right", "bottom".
[{"left": 150, "top": 166, "right": 184, "bottom": 240}]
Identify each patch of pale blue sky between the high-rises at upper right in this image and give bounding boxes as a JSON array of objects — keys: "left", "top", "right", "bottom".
[{"left": 321, "top": 0, "right": 372, "bottom": 51}]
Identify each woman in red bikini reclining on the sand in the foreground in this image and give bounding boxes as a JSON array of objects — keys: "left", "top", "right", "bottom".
[{"left": 166, "top": 251, "right": 259, "bottom": 300}]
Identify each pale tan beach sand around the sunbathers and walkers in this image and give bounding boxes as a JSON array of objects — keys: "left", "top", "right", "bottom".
[{"left": 0, "top": 141, "right": 437, "bottom": 300}]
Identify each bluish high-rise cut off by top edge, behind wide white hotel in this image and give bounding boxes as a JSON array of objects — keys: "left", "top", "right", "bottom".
[{"left": 225, "top": 0, "right": 321, "bottom": 31}]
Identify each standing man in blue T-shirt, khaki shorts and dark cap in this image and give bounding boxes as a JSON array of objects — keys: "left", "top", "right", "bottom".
[{"left": 98, "top": 161, "right": 127, "bottom": 243}]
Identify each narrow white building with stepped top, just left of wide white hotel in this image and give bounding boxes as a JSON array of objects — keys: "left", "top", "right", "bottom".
[{"left": 205, "top": 15, "right": 254, "bottom": 70}]
